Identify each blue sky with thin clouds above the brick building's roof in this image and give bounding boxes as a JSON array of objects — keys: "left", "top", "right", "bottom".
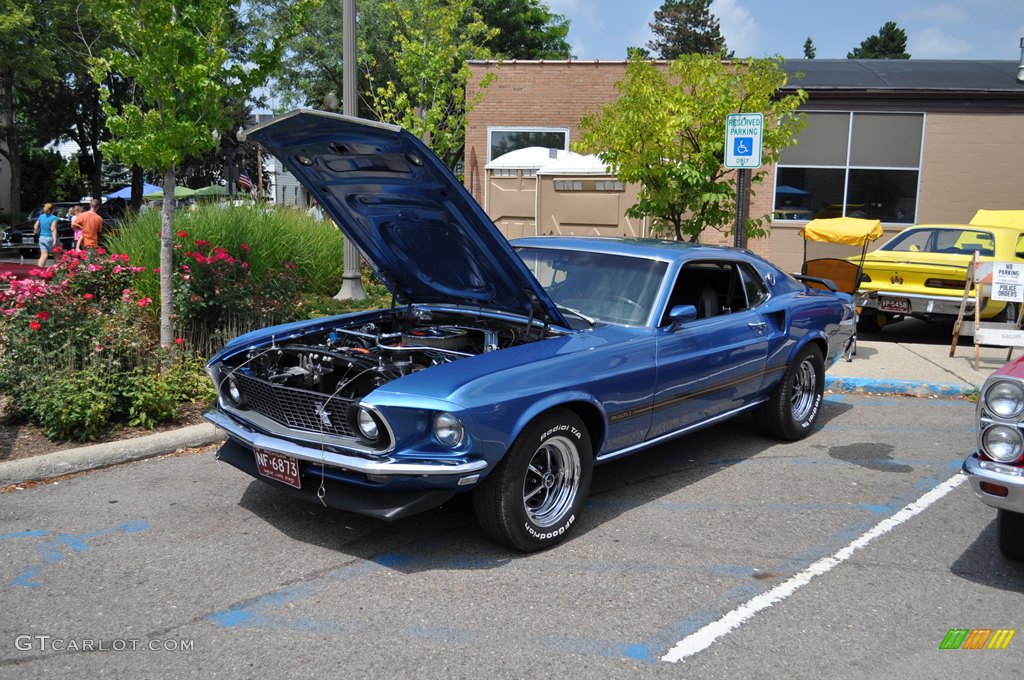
[{"left": 547, "top": 0, "right": 1024, "bottom": 59}]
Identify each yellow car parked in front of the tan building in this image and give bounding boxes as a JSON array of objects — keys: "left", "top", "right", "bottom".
[{"left": 850, "top": 210, "right": 1024, "bottom": 333}]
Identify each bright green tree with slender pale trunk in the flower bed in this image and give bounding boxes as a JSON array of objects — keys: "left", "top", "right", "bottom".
[{"left": 91, "top": 0, "right": 304, "bottom": 346}]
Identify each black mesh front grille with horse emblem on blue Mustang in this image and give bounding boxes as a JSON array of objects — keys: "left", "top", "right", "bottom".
[{"left": 233, "top": 372, "right": 354, "bottom": 437}]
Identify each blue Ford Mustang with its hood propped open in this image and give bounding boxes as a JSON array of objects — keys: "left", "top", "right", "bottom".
[{"left": 207, "top": 111, "right": 855, "bottom": 551}]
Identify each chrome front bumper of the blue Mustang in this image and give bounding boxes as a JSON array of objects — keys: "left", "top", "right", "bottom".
[{"left": 203, "top": 410, "right": 487, "bottom": 481}]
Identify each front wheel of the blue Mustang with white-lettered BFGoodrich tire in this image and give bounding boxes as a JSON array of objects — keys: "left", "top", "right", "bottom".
[{"left": 473, "top": 409, "right": 593, "bottom": 552}]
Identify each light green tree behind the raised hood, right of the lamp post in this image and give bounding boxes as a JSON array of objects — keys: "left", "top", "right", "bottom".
[{"left": 367, "top": 0, "right": 498, "bottom": 167}]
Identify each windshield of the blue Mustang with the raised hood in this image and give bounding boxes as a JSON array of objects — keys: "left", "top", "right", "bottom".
[{"left": 517, "top": 248, "right": 668, "bottom": 326}]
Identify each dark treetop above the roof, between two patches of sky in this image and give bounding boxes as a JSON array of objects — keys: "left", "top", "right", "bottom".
[{"left": 647, "top": 0, "right": 732, "bottom": 59}]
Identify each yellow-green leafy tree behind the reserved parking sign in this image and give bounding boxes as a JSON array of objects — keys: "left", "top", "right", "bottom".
[{"left": 575, "top": 54, "right": 807, "bottom": 242}]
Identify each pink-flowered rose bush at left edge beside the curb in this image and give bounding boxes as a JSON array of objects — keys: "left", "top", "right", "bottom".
[{"left": 0, "top": 251, "right": 211, "bottom": 440}]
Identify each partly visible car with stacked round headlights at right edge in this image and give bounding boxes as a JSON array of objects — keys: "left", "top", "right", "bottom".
[{"left": 964, "top": 356, "right": 1024, "bottom": 560}]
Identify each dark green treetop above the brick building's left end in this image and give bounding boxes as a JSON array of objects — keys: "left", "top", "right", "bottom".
[{"left": 473, "top": 0, "right": 572, "bottom": 59}]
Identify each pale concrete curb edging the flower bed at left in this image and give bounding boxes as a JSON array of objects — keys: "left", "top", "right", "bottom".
[{"left": 0, "top": 423, "right": 225, "bottom": 486}]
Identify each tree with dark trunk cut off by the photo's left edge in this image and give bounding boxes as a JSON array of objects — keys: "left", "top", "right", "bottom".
[{"left": 0, "top": 0, "right": 53, "bottom": 219}]
